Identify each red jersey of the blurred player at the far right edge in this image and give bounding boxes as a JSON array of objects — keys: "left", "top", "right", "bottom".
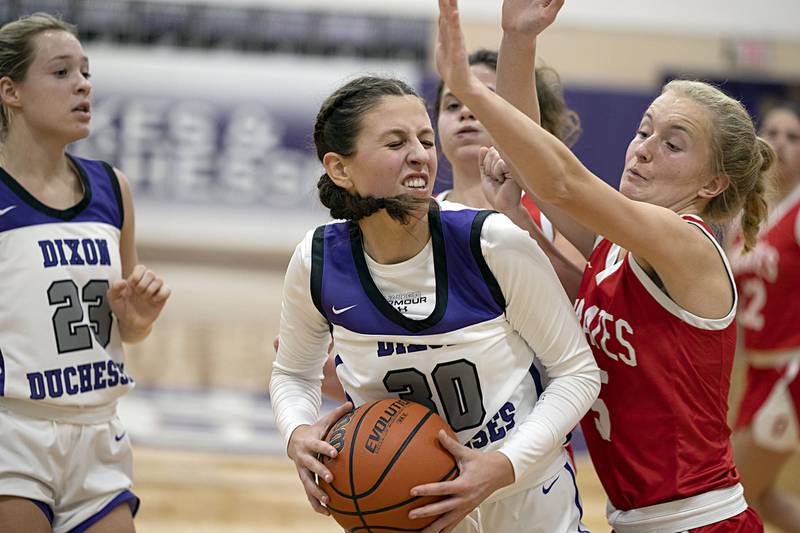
[{"left": 732, "top": 186, "right": 800, "bottom": 351}]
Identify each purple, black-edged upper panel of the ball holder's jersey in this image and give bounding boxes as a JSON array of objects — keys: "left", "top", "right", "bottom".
[{"left": 311, "top": 209, "right": 504, "bottom": 335}]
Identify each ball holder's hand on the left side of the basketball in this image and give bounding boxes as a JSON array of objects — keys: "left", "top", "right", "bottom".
[{"left": 287, "top": 402, "right": 353, "bottom": 516}]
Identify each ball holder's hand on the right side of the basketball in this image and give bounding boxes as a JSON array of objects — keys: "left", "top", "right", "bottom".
[{"left": 409, "top": 431, "right": 514, "bottom": 533}]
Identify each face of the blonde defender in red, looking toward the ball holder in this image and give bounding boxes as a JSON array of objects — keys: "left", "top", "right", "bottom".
[{"left": 619, "top": 92, "right": 712, "bottom": 211}]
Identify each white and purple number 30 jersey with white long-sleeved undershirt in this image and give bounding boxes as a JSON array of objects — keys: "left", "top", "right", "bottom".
[{"left": 270, "top": 204, "right": 599, "bottom": 483}]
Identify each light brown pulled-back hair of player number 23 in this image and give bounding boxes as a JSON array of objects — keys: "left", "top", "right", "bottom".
[{"left": 0, "top": 13, "right": 78, "bottom": 140}]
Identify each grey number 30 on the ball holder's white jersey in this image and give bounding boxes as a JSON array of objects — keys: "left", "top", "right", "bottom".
[{"left": 383, "top": 359, "right": 486, "bottom": 433}]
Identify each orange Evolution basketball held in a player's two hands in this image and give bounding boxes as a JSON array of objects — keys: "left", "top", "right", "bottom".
[{"left": 320, "top": 399, "right": 458, "bottom": 533}]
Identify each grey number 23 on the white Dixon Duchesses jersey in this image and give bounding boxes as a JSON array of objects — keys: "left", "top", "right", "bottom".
[{"left": 47, "top": 279, "right": 112, "bottom": 353}]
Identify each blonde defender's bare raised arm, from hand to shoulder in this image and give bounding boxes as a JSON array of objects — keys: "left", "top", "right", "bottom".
[{"left": 436, "top": 0, "right": 733, "bottom": 318}]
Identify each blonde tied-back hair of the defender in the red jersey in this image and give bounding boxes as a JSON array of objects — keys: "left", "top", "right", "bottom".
[{"left": 661, "top": 80, "right": 775, "bottom": 251}]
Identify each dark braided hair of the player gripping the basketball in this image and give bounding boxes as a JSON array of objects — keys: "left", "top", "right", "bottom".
[{"left": 314, "top": 76, "right": 428, "bottom": 224}]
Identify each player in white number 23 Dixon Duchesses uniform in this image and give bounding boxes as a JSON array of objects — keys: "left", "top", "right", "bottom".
[{"left": 0, "top": 14, "right": 170, "bottom": 533}]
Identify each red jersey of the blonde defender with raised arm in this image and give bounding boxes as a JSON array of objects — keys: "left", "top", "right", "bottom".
[{"left": 575, "top": 215, "right": 739, "bottom": 510}]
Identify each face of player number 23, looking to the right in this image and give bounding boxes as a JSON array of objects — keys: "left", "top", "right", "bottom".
[{"left": 5, "top": 30, "right": 92, "bottom": 145}]
